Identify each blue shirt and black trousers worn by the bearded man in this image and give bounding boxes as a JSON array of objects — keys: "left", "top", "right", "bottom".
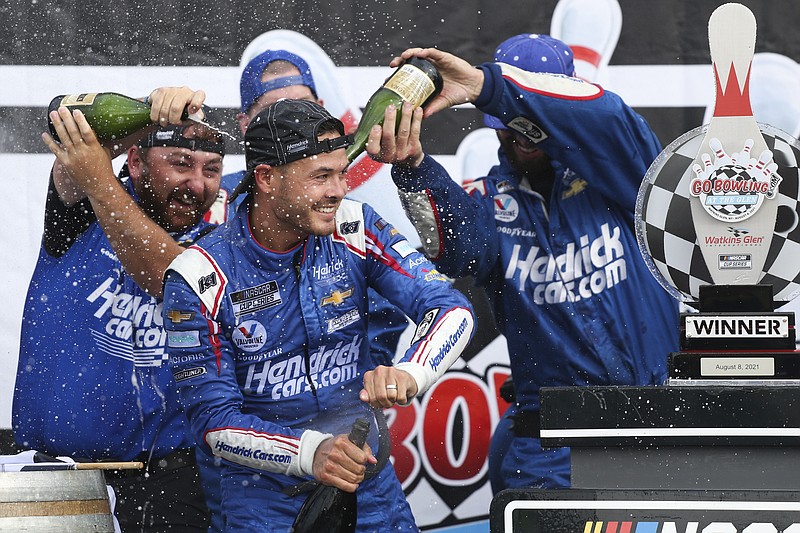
[{"left": 12, "top": 177, "right": 227, "bottom": 531}]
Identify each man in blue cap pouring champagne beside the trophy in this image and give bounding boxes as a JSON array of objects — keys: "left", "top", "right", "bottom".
[{"left": 367, "top": 34, "right": 678, "bottom": 492}]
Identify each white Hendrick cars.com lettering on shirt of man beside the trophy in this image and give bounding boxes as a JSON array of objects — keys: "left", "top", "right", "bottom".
[{"left": 505, "top": 220, "right": 628, "bottom": 305}]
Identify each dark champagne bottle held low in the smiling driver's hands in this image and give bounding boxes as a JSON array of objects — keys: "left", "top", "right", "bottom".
[{"left": 290, "top": 418, "right": 369, "bottom": 533}]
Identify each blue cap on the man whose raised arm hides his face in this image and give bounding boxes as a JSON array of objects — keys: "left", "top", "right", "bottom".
[{"left": 483, "top": 33, "right": 575, "bottom": 130}]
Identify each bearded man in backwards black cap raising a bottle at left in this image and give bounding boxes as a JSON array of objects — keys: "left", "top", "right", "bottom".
[{"left": 13, "top": 87, "right": 226, "bottom": 533}]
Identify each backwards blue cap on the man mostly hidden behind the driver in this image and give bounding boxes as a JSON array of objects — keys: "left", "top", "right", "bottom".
[{"left": 239, "top": 50, "right": 317, "bottom": 113}]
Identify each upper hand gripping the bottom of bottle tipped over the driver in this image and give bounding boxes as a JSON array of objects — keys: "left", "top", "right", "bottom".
[{"left": 389, "top": 48, "right": 483, "bottom": 117}]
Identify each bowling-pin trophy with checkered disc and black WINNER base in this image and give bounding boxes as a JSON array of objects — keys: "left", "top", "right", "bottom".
[{"left": 636, "top": 4, "right": 800, "bottom": 385}]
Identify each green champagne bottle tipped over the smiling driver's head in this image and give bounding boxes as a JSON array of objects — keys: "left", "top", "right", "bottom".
[{"left": 347, "top": 57, "right": 443, "bottom": 161}]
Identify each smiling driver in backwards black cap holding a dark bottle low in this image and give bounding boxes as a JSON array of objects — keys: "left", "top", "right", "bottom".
[{"left": 164, "top": 100, "right": 474, "bottom": 532}]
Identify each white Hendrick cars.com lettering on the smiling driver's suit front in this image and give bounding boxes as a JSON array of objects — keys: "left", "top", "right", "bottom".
[{"left": 244, "top": 335, "right": 363, "bottom": 400}]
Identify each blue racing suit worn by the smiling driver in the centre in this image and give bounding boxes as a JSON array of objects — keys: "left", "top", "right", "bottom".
[{"left": 164, "top": 200, "right": 474, "bottom": 531}]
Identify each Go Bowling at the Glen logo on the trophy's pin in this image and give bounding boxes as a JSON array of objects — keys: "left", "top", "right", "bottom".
[{"left": 689, "top": 137, "right": 781, "bottom": 222}]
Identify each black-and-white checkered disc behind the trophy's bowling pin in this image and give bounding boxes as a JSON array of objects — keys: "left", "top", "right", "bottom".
[{"left": 636, "top": 124, "right": 800, "bottom": 302}]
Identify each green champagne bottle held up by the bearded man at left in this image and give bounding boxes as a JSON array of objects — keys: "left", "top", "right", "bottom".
[{"left": 47, "top": 93, "right": 151, "bottom": 141}]
